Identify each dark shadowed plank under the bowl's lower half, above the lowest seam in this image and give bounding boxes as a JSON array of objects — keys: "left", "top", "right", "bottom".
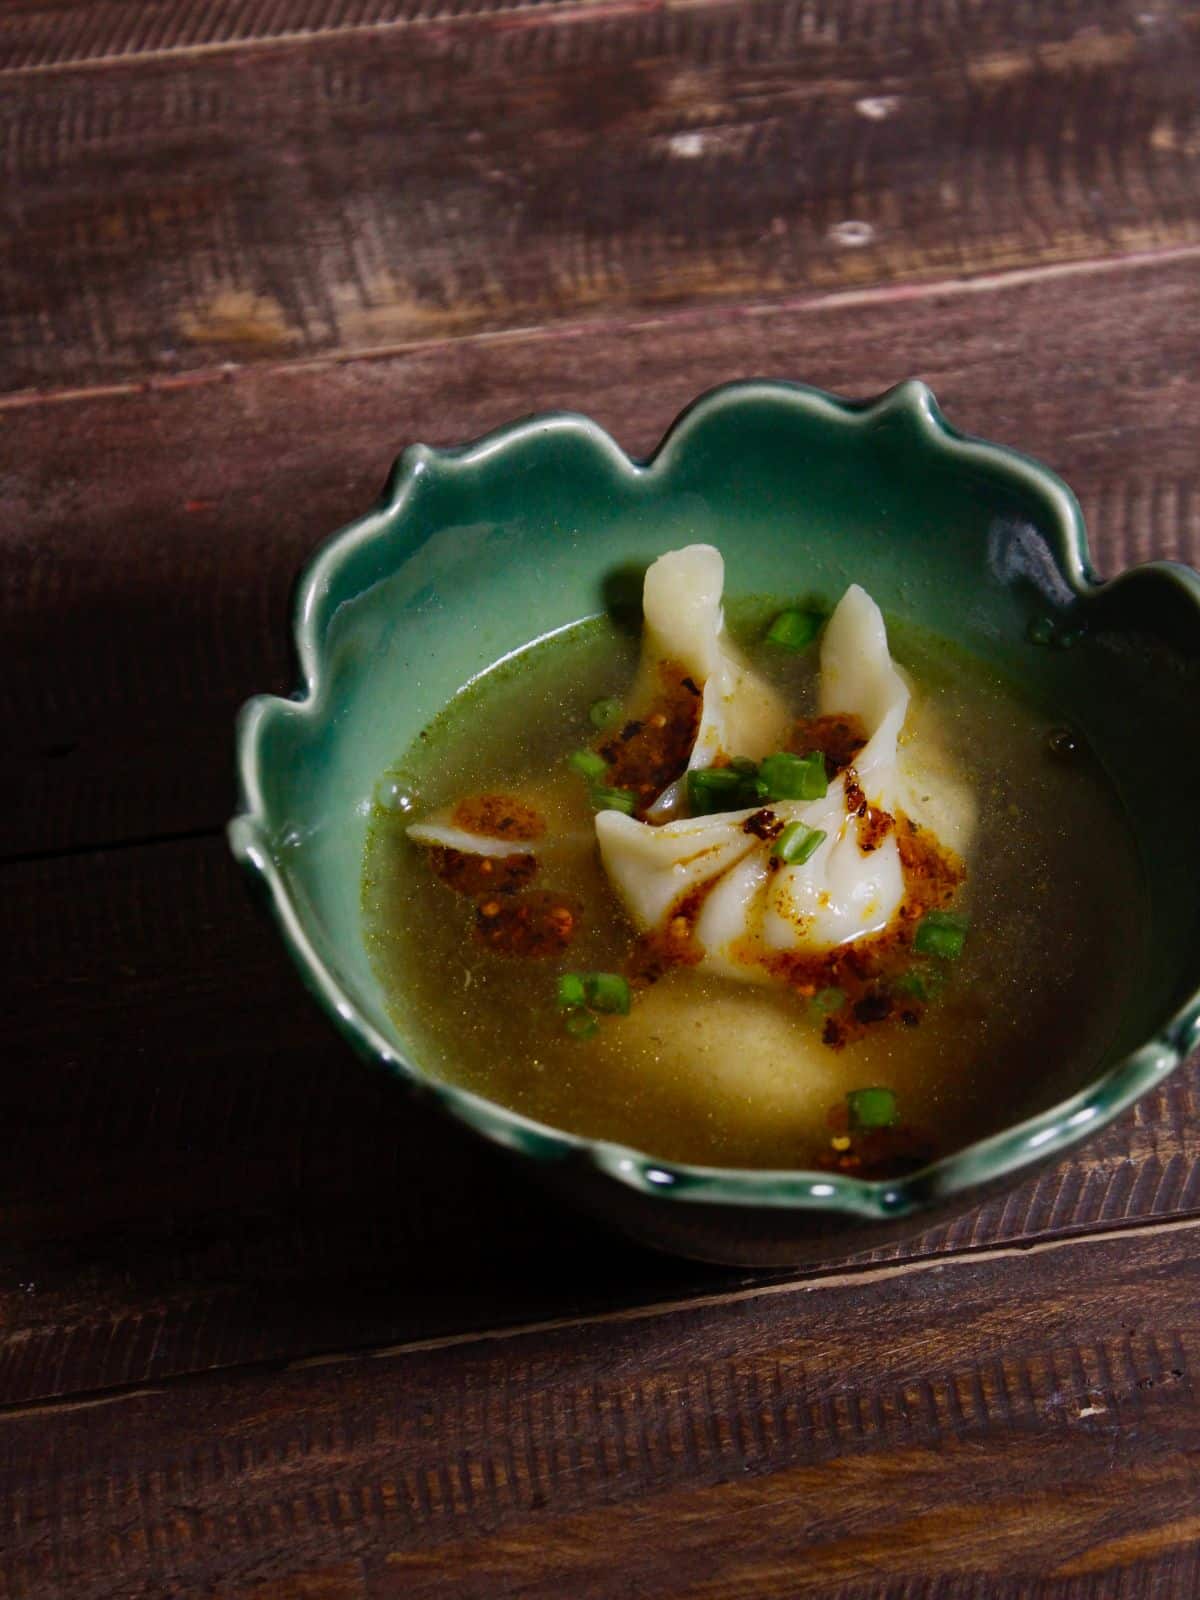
[{"left": 0, "top": 840, "right": 1200, "bottom": 1405}]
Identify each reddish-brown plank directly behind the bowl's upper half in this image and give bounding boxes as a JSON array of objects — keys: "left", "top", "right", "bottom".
[{"left": 0, "top": 251, "right": 1200, "bottom": 856}]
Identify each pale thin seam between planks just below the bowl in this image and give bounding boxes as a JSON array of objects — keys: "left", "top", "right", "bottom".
[{"left": 0, "top": 1214, "right": 1200, "bottom": 1427}]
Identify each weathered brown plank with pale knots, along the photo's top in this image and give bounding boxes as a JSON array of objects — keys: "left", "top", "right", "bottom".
[{"left": 0, "top": 0, "right": 1200, "bottom": 389}]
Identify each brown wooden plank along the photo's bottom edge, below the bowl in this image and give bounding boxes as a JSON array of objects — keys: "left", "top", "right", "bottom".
[{"left": 0, "top": 1224, "right": 1200, "bottom": 1600}]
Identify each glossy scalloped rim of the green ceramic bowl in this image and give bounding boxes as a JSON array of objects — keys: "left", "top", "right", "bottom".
[{"left": 227, "top": 379, "right": 1200, "bottom": 1221}]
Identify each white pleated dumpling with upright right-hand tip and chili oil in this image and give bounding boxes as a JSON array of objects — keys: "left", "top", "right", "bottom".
[{"left": 595, "top": 584, "right": 972, "bottom": 981}]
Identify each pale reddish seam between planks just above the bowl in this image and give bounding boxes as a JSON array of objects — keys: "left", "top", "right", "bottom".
[{"left": 0, "top": 245, "right": 1200, "bottom": 413}]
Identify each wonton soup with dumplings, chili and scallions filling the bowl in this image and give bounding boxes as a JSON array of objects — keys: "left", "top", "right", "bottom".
[{"left": 365, "top": 546, "right": 1139, "bottom": 1178}]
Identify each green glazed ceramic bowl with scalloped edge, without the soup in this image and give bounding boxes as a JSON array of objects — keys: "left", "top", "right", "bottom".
[{"left": 229, "top": 382, "right": 1200, "bottom": 1264}]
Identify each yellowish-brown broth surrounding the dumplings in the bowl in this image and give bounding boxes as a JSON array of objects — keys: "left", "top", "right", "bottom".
[{"left": 363, "top": 602, "right": 1142, "bottom": 1168}]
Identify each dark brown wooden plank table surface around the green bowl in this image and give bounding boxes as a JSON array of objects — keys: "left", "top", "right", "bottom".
[{"left": 0, "top": 0, "right": 1200, "bottom": 1600}]
